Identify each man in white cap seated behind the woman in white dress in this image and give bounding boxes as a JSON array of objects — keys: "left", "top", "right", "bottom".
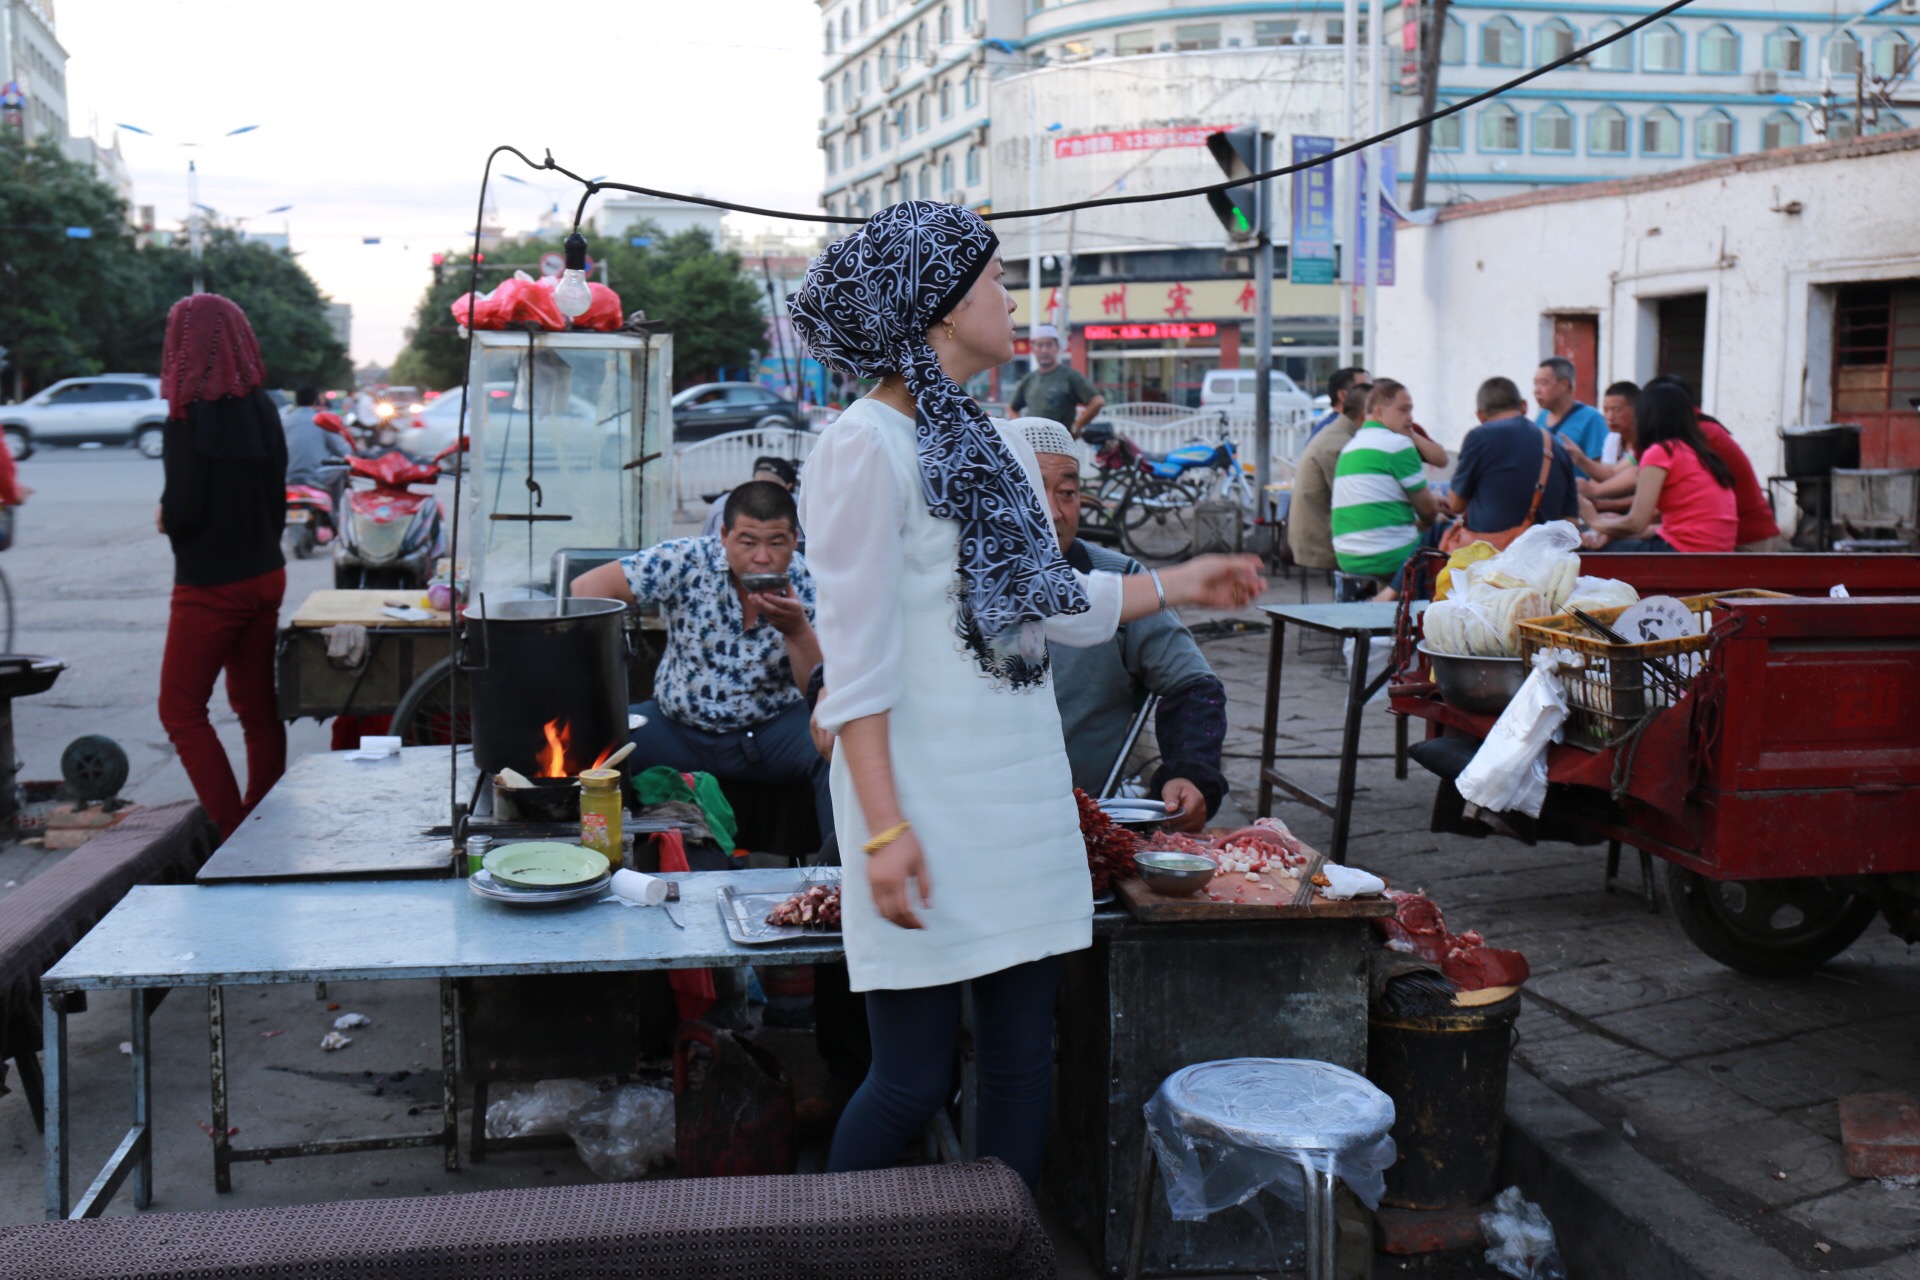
[{"left": 1020, "top": 418, "right": 1227, "bottom": 831}]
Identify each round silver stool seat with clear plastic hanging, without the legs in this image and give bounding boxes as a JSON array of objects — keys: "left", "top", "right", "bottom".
[{"left": 1146, "top": 1057, "right": 1394, "bottom": 1222}]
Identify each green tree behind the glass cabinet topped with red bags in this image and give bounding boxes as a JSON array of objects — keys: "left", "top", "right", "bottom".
[{"left": 394, "top": 223, "right": 766, "bottom": 388}]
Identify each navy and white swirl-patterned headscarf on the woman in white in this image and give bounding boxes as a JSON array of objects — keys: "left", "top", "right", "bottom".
[{"left": 787, "top": 200, "right": 1089, "bottom": 687}]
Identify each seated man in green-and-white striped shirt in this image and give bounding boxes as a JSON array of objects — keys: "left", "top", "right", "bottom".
[{"left": 1332, "top": 378, "right": 1438, "bottom": 599}]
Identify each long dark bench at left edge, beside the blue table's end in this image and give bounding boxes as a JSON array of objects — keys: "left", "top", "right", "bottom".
[{"left": 0, "top": 800, "right": 217, "bottom": 1132}]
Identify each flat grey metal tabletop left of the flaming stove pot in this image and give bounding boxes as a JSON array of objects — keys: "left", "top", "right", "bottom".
[{"left": 196, "top": 747, "right": 478, "bottom": 885}]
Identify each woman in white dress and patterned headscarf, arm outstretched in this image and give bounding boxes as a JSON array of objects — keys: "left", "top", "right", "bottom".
[{"left": 789, "top": 201, "right": 1263, "bottom": 1186}]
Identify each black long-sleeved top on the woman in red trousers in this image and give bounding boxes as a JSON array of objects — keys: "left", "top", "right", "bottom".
[{"left": 159, "top": 391, "right": 286, "bottom": 587}]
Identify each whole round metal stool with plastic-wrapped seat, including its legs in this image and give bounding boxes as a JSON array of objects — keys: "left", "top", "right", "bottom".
[{"left": 1125, "top": 1057, "right": 1394, "bottom": 1280}]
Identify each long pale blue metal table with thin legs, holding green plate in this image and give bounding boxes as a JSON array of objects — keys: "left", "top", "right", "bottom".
[{"left": 40, "top": 871, "right": 841, "bottom": 1219}]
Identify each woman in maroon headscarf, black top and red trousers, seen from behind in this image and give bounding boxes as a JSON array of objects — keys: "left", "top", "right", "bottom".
[{"left": 159, "top": 294, "right": 286, "bottom": 837}]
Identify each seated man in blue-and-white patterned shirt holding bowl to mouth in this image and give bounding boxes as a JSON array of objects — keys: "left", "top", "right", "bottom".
[{"left": 572, "top": 480, "right": 833, "bottom": 835}]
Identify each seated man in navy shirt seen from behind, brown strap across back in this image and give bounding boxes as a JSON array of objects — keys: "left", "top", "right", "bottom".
[{"left": 1448, "top": 378, "right": 1580, "bottom": 547}]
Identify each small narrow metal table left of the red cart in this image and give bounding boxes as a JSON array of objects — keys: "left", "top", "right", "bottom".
[{"left": 1260, "top": 603, "right": 1425, "bottom": 862}]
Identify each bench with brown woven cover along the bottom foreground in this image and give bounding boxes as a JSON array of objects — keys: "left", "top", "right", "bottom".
[{"left": 0, "top": 1159, "right": 1056, "bottom": 1280}]
